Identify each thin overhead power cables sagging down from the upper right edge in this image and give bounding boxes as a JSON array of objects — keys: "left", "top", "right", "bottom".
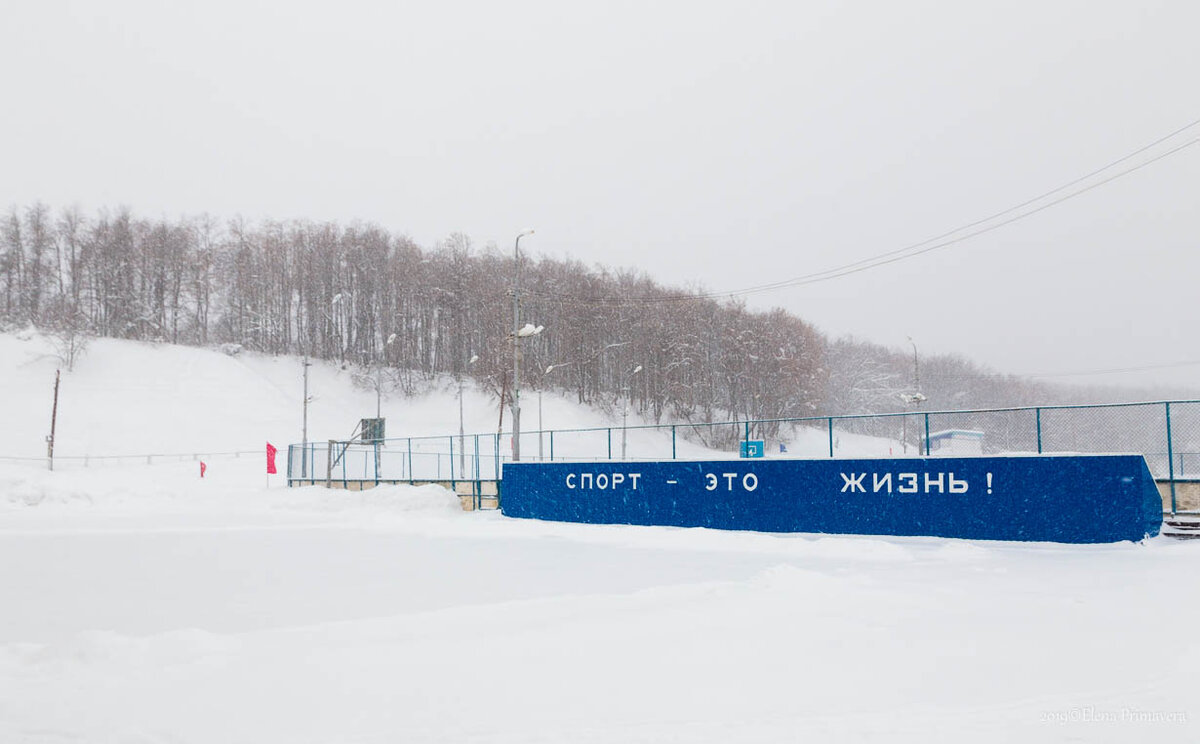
[{"left": 532, "top": 119, "right": 1200, "bottom": 305}]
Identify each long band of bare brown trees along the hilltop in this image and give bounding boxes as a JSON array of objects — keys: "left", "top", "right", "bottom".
[{"left": 0, "top": 204, "right": 1113, "bottom": 437}]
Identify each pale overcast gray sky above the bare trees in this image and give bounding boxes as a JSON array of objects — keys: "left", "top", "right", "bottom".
[{"left": 0, "top": 0, "right": 1200, "bottom": 384}]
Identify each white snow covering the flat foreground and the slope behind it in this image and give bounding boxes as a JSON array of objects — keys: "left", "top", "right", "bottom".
[{"left": 0, "top": 335, "right": 1200, "bottom": 744}]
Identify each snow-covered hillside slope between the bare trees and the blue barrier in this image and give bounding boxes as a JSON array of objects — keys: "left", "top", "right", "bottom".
[{"left": 0, "top": 331, "right": 900, "bottom": 477}]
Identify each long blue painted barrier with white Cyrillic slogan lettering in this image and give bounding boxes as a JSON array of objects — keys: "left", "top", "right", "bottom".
[{"left": 502, "top": 455, "right": 1163, "bottom": 542}]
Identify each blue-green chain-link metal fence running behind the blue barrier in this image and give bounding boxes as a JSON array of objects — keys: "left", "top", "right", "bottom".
[{"left": 288, "top": 401, "right": 1200, "bottom": 514}]
